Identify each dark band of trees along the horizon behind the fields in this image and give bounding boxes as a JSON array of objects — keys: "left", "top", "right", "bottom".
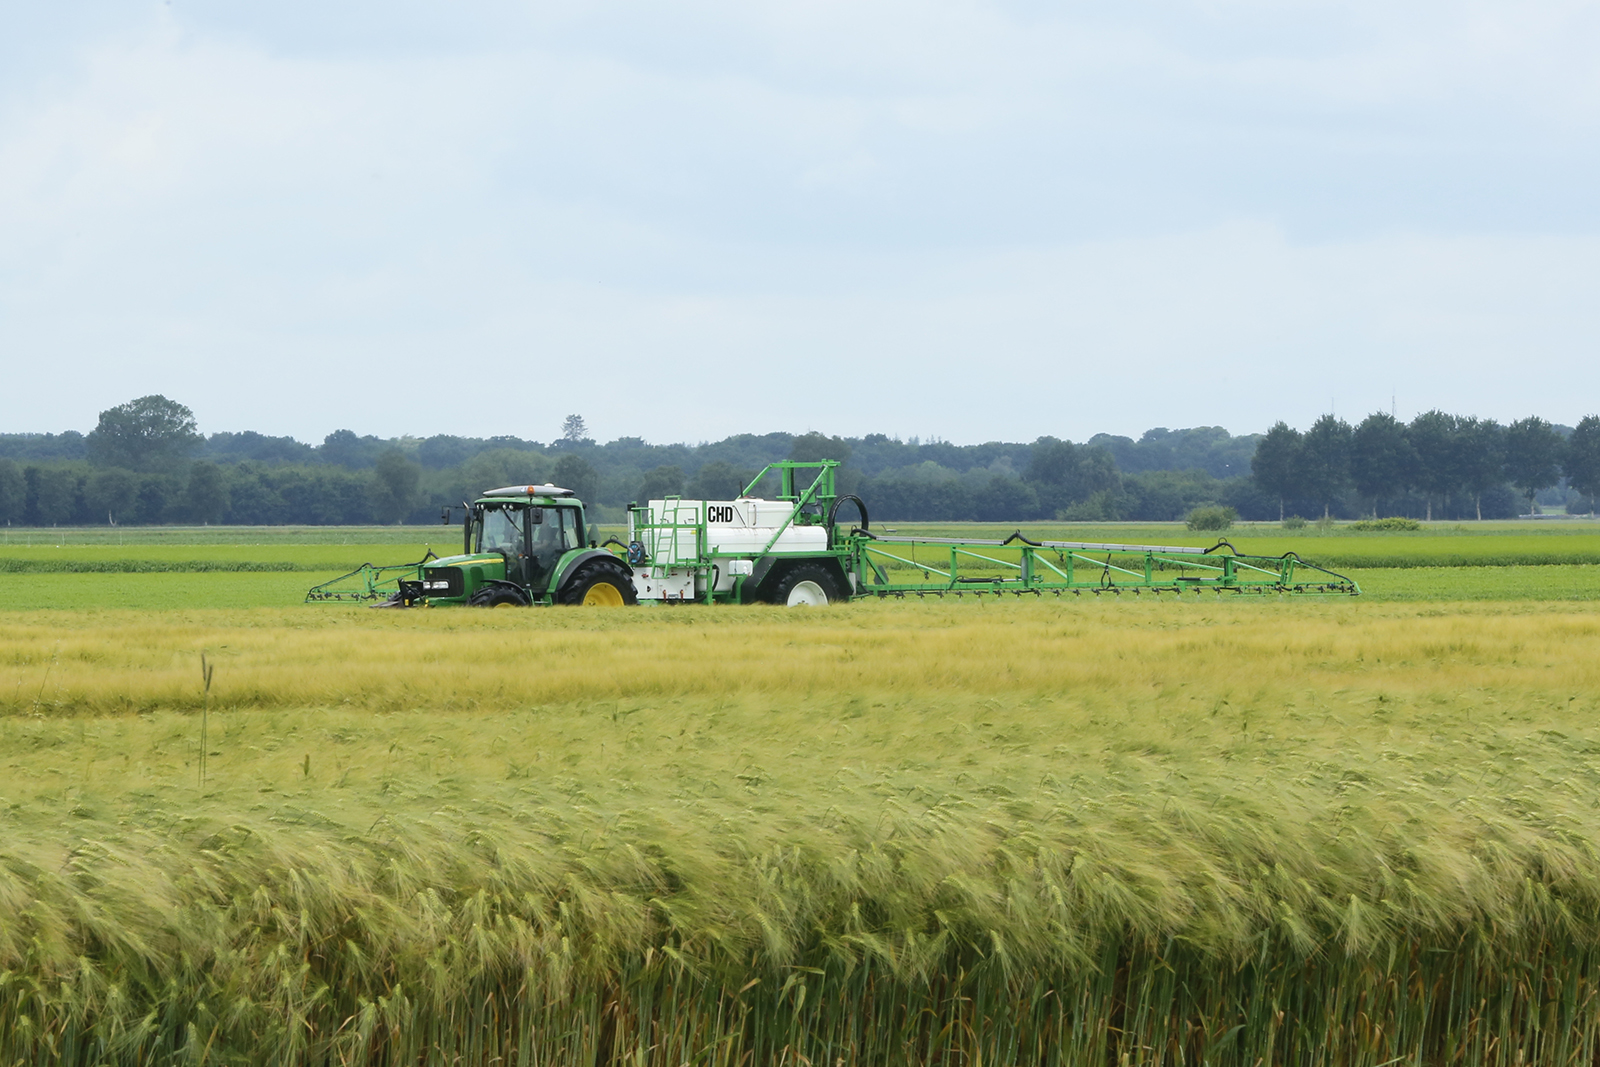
[{"left": 0, "top": 397, "right": 1600, "bottom": 526}]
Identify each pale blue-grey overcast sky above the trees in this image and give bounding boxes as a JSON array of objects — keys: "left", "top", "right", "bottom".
[{"left": 0, "top": 0, "right": 1600, "bottom": 443}]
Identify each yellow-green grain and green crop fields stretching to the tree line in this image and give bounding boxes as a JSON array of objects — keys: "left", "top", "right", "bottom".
[{"left": 0, "top": 523, "right": 1600, "bottom": 1067}]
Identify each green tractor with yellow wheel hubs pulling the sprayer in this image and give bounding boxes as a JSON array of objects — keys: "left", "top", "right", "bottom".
[{"left": 384, "top": 485, "right": 638, "bottom": 608}]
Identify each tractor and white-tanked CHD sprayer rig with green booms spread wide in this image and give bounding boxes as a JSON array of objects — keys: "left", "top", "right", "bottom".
[{"left": 306, "top": 459, "right": 1362, "bottom": 608}]
